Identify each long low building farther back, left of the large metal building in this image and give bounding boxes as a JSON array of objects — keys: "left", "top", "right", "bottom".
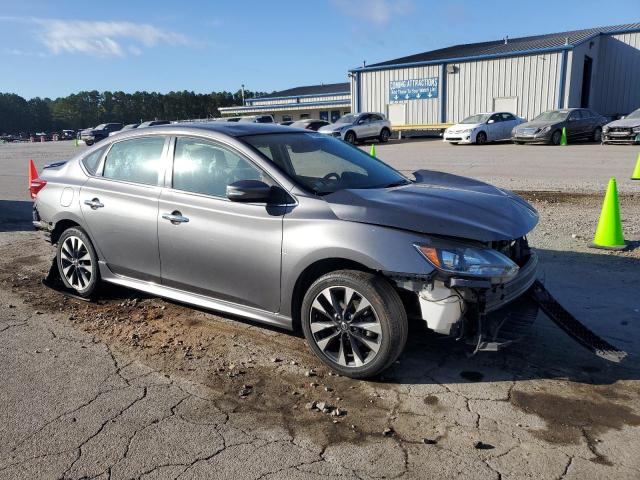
[{"left": 219, "top": 83, "right": 351, "bottom": 122}]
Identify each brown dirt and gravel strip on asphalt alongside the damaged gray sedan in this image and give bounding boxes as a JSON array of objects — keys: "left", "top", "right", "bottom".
[{"left": 0, "top": 236, "right": 400, "bottom": 445}]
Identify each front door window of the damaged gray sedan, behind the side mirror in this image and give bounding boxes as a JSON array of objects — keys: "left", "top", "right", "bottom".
[{"left": 172, "top": 137, "right": 274, "bottom": 197}]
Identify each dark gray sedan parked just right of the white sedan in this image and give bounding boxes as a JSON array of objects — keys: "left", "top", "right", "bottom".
[{"left": 511, "top": 108, "right": 607, "bottom": 145}]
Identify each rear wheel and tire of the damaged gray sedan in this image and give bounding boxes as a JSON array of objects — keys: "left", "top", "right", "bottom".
[{"left": 56, "top": 227, "right": 100, "bottom": 298}]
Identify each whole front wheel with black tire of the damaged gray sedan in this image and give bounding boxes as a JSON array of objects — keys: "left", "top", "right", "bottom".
[{"left": 301, "top": 270, "right": 408, "bottom": 378}]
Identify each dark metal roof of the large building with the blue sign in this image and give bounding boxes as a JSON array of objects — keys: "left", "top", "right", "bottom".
[{"left": 354, "top": 23, "right": 640, "bottom": 71}]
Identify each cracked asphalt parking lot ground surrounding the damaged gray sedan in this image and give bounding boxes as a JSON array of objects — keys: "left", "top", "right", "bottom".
[{"left": 0, "top": 139, "right": 640, "bottom": 479}]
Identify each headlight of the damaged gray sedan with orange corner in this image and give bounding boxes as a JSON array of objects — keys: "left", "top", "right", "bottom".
[{"left": 414, "top": 243, "right": 520, "bottom": 282}]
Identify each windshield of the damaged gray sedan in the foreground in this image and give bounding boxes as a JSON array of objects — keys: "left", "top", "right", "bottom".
[{"left": 242, "top": 132, "right": 410, "bottom": 195}]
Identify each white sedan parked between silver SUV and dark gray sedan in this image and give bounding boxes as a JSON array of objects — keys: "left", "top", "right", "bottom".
[{"left": 444, "top": 112, "right": 526, "bottom": 145}]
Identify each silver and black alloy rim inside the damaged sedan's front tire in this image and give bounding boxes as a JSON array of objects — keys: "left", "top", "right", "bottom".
[{"left": 309, "top": 286, "right": 382, "bottom": 367}]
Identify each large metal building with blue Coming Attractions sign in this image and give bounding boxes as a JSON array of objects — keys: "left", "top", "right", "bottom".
[{"left": 349, "top": 23, "right": 640, "bottom": 125}]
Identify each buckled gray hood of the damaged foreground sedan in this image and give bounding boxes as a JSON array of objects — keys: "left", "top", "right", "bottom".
[{"left": 323, "top": 170, "right": 538, "bottom": 242}]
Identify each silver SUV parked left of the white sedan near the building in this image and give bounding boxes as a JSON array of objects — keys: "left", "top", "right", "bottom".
[{"left": 318, "top": 113, "right": 391, "bottom": 143}]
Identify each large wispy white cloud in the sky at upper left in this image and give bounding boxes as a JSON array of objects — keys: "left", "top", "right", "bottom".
[{"left": 0, "top": 17, "right": 190, "bottom": 57}]
